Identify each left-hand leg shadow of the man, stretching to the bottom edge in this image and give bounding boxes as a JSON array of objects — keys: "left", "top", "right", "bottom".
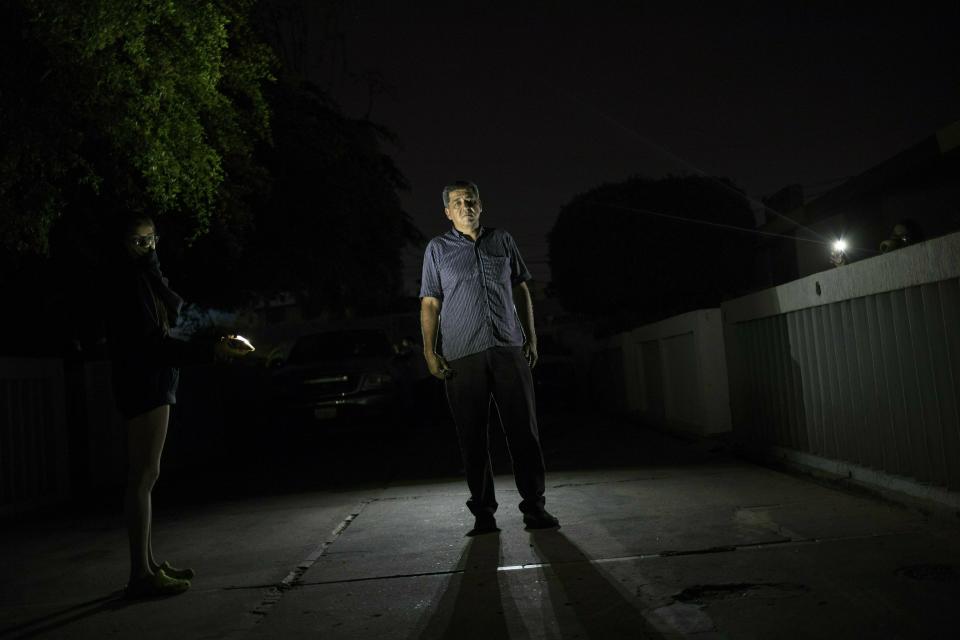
[{"left": 411, "top": 532, "right": 510, "bottom": 640}]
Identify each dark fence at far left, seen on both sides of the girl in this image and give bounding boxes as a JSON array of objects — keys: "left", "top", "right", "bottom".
[{"left": 0, "top": 358, "right": 269, "bottom": 515}]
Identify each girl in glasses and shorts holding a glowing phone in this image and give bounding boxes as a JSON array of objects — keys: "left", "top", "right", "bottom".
[{"left": 105, "top": 216, "right": 252, "bottom": 598}]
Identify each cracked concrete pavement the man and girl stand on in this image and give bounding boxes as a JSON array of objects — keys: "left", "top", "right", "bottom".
[{"left": 0, "top": 420, "right": 960, "bottom": 640}]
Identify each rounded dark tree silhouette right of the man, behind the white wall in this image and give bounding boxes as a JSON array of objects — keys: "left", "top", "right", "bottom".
[{"left": 549, "top": 176, "right": 754, "bottom": 329}]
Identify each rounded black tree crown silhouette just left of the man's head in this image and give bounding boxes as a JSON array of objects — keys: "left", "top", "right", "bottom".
[{"left": 251, "top": 79, "right": 421, "bottom": 314}]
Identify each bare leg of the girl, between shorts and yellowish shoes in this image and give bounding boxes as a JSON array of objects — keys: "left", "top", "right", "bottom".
[{"left": 124, "top": 405, "right": 170, "bottom": 582}]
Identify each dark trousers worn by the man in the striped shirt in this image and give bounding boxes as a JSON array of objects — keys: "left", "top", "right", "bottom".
[{"left": 446, "top": 347, "right": 545, "bottom": 515}]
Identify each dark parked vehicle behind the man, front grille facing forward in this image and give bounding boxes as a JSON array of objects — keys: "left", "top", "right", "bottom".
[{"left": 272, "top": 329, "right": 404, "bottom": 422}]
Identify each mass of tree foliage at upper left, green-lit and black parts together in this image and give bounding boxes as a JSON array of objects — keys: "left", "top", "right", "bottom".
[{"left": 0, "top": 0, "right": 419, "bottom": 353}]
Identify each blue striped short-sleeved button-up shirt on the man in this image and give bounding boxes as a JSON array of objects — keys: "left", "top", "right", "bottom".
[{"left": 420, "top": 228, "right": 531, "bottom": 360}]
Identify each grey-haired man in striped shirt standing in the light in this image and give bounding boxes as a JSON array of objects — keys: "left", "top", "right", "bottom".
[{"left": 420, "top": 181, "right": 560, "bottom": 535}]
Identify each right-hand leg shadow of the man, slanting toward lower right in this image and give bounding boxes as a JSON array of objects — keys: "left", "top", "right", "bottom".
[{"left": 530, "top": 529, "right": 664, "bottom": 639}]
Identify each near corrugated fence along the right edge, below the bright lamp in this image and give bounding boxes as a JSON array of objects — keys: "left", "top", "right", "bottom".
[{"left": 724, "top": 236, "right": 960, "bottom": 491}]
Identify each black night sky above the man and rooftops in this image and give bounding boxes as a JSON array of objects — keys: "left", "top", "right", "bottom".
[{"left": 315, "top": 0, "right": 960, "bottom": 280}]
